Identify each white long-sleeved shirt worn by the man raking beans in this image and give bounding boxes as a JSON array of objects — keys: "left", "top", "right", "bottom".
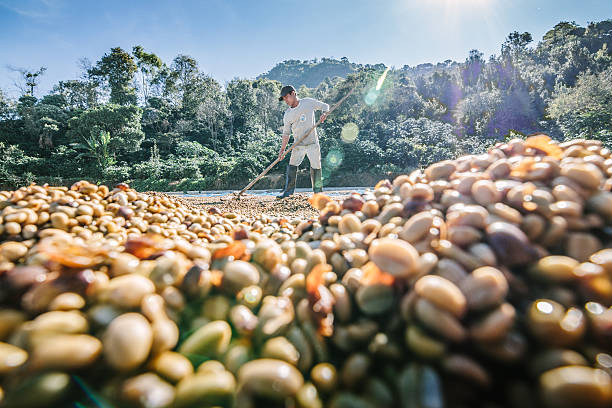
[{"left": 283, "top": 98, "right": 329, "bottom": 146}]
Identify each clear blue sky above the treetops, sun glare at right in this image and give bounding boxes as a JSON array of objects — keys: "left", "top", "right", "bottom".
[{"left": 0, "top": 0, "right": 612, "bottom": 95}]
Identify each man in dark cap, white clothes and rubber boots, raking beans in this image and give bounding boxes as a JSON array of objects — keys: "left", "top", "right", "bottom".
[{"left": 278, "top": 85, "right": 329, "bottom": 198}]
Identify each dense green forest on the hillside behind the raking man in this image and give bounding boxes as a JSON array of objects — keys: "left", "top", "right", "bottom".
[{"left": 0, "top": 20, "right": 612, "bottom": 191}]
